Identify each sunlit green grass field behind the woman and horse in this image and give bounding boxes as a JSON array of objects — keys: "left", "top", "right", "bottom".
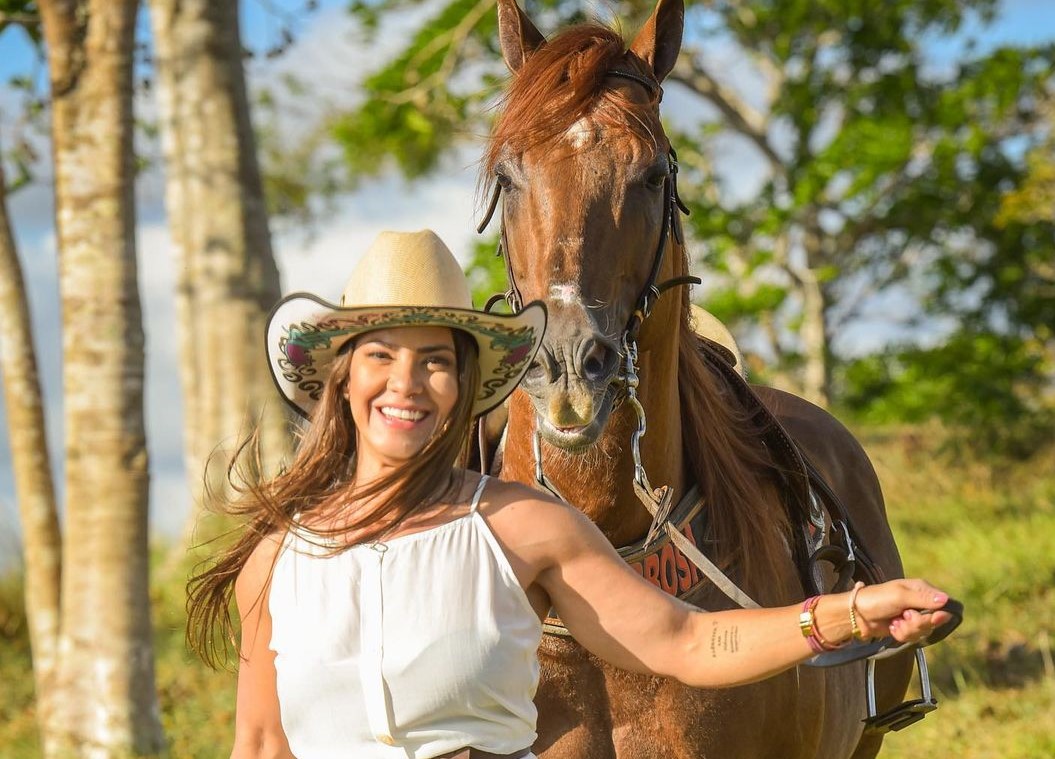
[{"left": 0, "top": 431, "right": 1055, "bottom": 759}]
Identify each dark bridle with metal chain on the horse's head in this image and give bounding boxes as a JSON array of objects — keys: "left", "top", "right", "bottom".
[{"left": 477, "top": 69, "right": 702, "bottom": 543}]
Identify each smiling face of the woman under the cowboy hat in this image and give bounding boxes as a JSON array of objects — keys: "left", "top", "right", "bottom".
[{"left": 347, "top": 327, "right": 458, "bottom": 467}]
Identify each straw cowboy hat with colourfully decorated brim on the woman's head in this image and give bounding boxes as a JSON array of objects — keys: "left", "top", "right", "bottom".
[{"left": 267, "top": 229, "right": 545, "bottom": 417}]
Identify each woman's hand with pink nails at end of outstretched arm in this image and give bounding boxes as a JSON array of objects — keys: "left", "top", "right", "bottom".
[{"left": 855, "top": 580, "right": 953, "bottom": 643}]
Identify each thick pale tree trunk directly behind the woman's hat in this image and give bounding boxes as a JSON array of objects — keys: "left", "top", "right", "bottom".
[{"left": 150, "top": 0, "right": 288, "bottom": 544}]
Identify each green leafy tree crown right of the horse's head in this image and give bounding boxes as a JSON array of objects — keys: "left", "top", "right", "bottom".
[{"left": 678, "top": 5, "right": 1053, "bottom": 394}]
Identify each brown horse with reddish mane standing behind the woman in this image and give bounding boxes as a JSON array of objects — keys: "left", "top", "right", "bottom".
[{"left": 485, "top": 0, "right": 912, "bottom": 759}]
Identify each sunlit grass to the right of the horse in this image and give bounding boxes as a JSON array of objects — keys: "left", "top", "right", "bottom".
[{"left": 865, "top": 433, "right": 1055, "bottom": 759}]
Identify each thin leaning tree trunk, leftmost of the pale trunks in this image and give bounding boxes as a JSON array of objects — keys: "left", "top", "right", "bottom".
[{"left": 0, "top": 130, "right": 62, "bottom": 739}]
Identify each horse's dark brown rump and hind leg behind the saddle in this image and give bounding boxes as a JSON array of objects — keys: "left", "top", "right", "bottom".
[{"left": 754, "top": 386, "right": 914, "bottom": 759}]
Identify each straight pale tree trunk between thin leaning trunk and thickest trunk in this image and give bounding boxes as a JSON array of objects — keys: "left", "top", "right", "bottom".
[{"left": 40, "top": 0, "right": 164, "bottom": 757}]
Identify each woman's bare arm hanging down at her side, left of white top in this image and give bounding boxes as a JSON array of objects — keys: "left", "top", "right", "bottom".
[{"left": 231, "top": 535, "right": 294, "bottom": 759}]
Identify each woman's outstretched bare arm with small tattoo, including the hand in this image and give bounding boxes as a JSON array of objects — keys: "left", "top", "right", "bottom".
[{"left": 521, "top": 491, "right": 950, "bottom": 687}]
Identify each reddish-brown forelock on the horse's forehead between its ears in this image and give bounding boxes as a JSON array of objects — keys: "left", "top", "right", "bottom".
[{"left": 483, "top": 24, "right": 658, "bottom": 177}]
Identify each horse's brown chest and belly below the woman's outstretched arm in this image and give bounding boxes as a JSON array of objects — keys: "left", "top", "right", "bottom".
[{"left": 536, "top": 635, "right": 846, "bottom": 759}]
